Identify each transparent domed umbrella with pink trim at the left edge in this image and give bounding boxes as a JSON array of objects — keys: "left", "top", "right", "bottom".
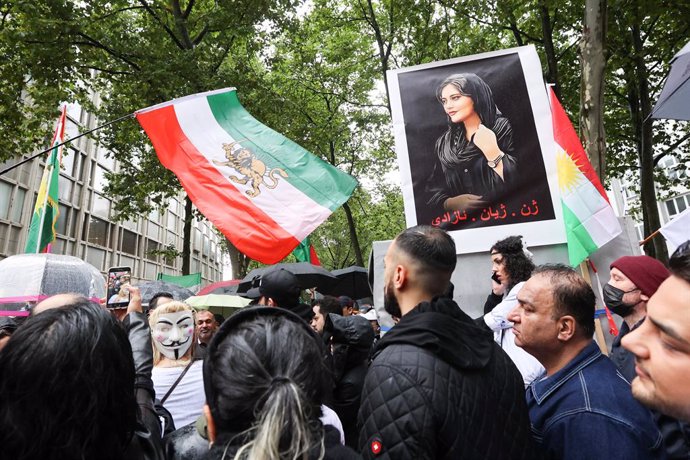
[{"left": 0, "top": 254, "right": 105, "bottom": 316}]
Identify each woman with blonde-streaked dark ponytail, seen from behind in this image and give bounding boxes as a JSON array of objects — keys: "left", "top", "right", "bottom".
[{"left": 199, "top": 307, "right": 359, "bottom": 460}]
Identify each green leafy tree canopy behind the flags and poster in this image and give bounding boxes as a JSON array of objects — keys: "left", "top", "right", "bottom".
[{"left": 5, "top": 0, "right": 690, "bottom": 271}]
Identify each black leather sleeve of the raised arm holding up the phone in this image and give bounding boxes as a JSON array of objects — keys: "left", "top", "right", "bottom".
[{"left": 122, "top": 313, "right": 164, "bottom": 460}]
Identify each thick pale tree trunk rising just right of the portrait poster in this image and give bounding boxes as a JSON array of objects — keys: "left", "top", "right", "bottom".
[{"left": 580, "top": 0, "right": 606, "bottom": 183}]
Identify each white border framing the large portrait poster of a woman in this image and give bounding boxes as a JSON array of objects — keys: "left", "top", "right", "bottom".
[{"left": 387, "top": 46, "right": 566, "bottom": 254}]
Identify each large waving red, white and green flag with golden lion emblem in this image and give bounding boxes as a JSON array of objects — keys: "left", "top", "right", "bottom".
[{"left": 136, "top": 88, "right": 357, "bottom": 264}]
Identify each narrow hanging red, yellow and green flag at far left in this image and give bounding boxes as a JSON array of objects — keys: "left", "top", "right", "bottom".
[{"left": 24, "top": 106, "right": 67, "bottom": 253}]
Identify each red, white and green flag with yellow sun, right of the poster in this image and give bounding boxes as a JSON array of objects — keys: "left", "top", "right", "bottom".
[{"left": 549, "top": 88, "right": 622, "bottom": 266}]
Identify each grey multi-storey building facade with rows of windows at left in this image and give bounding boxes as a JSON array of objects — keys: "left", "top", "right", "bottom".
[{"left": 0, "top": 104, "right": 223, "bottom": 285}]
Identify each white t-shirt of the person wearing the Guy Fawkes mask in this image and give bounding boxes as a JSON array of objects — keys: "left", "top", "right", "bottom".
[{"left": 151, "top": 360, "right": 206, "bottom": 429}]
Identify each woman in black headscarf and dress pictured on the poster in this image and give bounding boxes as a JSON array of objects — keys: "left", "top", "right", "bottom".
[{"left": 426, "top": 73, "right": 517, "bottom": 212}]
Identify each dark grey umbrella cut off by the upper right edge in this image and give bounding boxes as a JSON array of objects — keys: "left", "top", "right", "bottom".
[{"left": 651, "top": 42, "right": 690, "bottom": 120}]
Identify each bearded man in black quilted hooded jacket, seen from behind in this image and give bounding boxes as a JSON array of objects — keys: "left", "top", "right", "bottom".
[{"left": 358, "top": 226, "right": 539, "bottom": 460}]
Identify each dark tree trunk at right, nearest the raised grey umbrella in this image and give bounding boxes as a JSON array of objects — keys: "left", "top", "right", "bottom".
[{"left": 631, "top": 21, "right": 668, "bottom": 264}]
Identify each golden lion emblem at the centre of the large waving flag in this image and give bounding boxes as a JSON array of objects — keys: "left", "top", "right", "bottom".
[{"left": 213, "top": 141, "right": 288, "bottom": 198}]
